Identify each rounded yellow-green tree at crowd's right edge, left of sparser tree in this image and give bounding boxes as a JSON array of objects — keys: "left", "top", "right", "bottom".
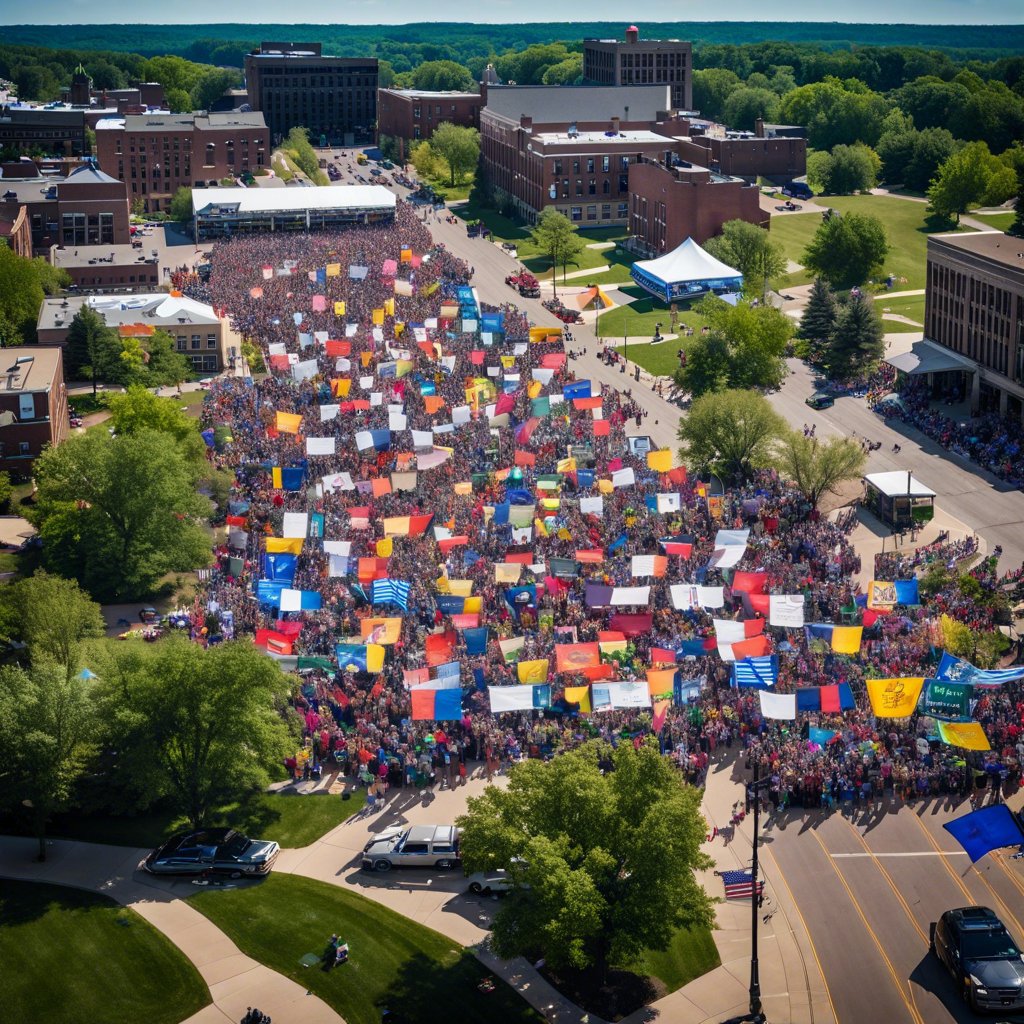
[{"left": 679, "top": 390, "right": 785, "bottom": 477}]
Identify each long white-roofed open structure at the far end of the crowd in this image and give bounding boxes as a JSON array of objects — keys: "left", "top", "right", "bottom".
[{"left": 193, "top": 185, "right": 395, "bottom": 242}]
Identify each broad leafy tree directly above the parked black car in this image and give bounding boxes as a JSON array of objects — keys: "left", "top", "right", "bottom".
[{"left": 97, "top": 637, "right": 294, "bottom": 827}]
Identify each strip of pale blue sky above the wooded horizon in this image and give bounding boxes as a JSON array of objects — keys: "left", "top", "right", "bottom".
[{"left": 6, "top": 0, "right": 1024, "bottom": 24}]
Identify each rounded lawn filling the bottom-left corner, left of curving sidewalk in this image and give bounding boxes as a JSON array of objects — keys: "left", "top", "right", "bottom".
[{"left": 0, "top": 880, "right": 211, "bottom": 1024}]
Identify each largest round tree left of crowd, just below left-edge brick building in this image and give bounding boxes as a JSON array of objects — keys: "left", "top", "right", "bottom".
[{"left": 31, "top": 429, "right": 210, "bottom": 600}]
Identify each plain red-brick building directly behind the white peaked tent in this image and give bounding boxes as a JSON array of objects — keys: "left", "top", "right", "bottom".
[{"left": 629, "top": 155, "right": 770, "bottom": 256}]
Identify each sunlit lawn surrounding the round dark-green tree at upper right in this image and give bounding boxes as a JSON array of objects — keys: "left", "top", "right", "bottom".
[{"left": 771, "top": 196, "right": 969, "bottom": 291}]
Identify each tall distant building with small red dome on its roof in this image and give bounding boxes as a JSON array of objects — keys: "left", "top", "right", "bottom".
[{"left": 583, "top": 25, "right": 693, "bottom": 111}]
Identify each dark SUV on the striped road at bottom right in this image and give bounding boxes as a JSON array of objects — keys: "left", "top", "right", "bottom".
[{"left": 932, "top": 906, "right": 1024, "bottom": 1011}]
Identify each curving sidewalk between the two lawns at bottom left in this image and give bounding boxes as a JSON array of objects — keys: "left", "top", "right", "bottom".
[{"left": 0, "top": 836, "right": 344, "bottom": 1024}]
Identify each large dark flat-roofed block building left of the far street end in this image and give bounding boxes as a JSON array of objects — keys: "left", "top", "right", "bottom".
[{"left": 245, "top": 42, "right": 377, "bottom": 145}]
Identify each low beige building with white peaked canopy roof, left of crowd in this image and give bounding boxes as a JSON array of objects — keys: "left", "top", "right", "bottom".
[{"left": 37, "top": 292, "right": 239, "bottom": 374}]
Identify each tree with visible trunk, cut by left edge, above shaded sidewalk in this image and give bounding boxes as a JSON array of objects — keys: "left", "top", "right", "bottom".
[{"left": 0, "top": 662, "right": 96, "bottom": 860}]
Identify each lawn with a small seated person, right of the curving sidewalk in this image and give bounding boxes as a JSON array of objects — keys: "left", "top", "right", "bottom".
[{"left": 189, "top": 862, "right": 543, "bottom": 1024}]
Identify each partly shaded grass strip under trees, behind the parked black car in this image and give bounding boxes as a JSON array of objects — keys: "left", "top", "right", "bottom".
[{"left": 33, "top": 790, "right": 366, "bottom": 848}]
